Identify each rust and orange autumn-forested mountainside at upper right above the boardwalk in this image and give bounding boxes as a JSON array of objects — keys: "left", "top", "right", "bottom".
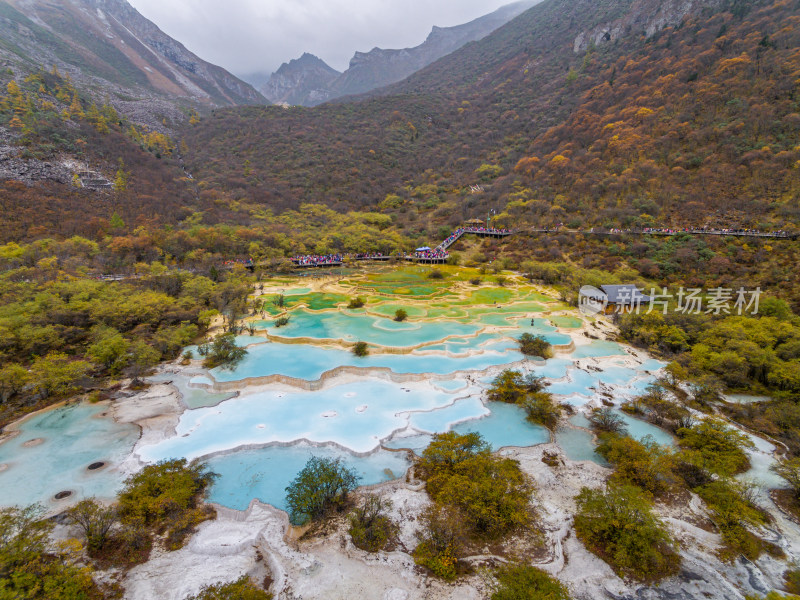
[{"left": 187, "top": 0, "right": 800, "bottom": 232}]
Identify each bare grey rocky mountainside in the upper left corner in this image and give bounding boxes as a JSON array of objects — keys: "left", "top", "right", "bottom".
[{"left": 0, "top": 0, "right": 265, "bottom": 122}]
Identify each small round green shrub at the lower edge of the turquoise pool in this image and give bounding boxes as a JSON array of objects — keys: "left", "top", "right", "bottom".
[{"left": 286, "top": 456, "right": 361, "bottom": 525}]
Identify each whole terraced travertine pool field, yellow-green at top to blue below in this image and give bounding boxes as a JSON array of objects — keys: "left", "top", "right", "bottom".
[{"left": 0, "top": 266, "right": 700, "bottom": 509}]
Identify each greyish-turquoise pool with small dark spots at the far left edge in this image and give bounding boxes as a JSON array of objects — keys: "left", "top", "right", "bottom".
[{"left": 0, "top": 403, "right": 139, "bottom": 506}]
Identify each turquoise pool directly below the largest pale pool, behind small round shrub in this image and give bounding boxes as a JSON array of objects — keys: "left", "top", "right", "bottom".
[{"left": 207, "top": 444, "right": 410, "bottom": 510}]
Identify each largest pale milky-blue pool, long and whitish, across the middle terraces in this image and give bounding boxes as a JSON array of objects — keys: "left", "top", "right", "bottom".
[{"left": 139, "top": 379, "right": 462, "bottom": 462}]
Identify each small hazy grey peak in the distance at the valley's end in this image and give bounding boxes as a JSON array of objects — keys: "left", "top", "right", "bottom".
[{"left": 259, "top": 52, "right": 341, "bottom": 106}]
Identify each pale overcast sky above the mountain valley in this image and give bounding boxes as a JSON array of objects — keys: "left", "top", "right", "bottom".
[{"left": 128, "top": 0, "right": 513, "bottom": 76}]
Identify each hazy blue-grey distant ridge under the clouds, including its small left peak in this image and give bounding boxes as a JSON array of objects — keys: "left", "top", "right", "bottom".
[{"left": 260, "top": 0, "right": 541, "bottom": 106}]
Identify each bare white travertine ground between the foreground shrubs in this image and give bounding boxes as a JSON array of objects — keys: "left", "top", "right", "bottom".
[{"left": 63, "top": 290, "right": 800, "bottom": 600}]
